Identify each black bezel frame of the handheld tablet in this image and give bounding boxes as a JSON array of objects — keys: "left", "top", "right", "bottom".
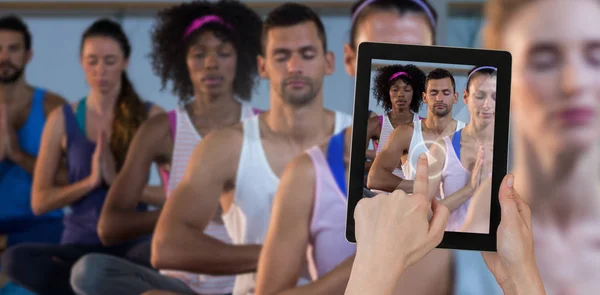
[{"left": 346, "top": 42, "right": 512, "bottom": 251}]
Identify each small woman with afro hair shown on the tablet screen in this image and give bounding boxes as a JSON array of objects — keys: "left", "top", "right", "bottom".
[{"left": 373, "top": 64, "right": 426, "bottom": 177}]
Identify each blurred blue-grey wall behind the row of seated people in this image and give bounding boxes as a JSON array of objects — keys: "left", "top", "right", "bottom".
[{"left": 0, "top": 0, "right": 485, "bottom": 183}]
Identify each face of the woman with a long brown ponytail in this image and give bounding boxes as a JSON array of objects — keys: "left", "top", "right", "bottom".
[{"left": 81, "top": 37, "right": 128, "bottom": 94}]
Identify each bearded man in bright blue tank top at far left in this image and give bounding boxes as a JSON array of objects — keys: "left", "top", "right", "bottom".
[{"left": 0, "top": 16, "right": 68, "bottom": 248}]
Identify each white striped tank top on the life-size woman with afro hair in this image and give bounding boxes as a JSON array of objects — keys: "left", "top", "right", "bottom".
[{"left": 160, "top": 102, "right": 256, "bottom": 294}]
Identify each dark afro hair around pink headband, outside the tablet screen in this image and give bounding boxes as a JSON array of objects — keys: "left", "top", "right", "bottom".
[{"left": 150, "top": 0, "right": 262, "bottom": 100}]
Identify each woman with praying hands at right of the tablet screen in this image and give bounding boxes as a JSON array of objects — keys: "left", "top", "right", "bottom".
[{"left": 429, "top": 66, "right": 497, "bottom": 233}]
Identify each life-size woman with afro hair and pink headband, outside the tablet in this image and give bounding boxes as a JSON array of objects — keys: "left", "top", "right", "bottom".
[{"left": 66, "top": 0, "right": 262, "bottom": 294}]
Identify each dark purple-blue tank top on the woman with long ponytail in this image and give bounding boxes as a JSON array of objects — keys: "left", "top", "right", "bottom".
[{"left": 61, "top": 98, "right": 151, "bottom": 245}]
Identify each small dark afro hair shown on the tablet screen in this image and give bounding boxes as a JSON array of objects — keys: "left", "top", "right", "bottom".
[{"left": 373, "top": 64, "right": 425, "bottom": 113}]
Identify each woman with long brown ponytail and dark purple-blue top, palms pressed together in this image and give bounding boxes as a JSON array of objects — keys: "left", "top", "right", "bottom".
[{"left": 2, "top": 19, "right": 163, "bottom": 294}]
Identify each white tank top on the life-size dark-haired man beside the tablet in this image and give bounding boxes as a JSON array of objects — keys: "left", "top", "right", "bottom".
[{"left": 223, "top": 112, "right": 352, "bottom": 295}]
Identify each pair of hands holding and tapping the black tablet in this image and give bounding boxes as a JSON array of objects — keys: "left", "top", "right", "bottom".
[{"left": 346, "top": 151, "right": 545, "bottom": 295}]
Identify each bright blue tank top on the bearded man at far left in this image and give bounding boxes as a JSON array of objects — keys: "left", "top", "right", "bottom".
[{"left": 0, "top": 88, "right": 63, "bottom": 220}]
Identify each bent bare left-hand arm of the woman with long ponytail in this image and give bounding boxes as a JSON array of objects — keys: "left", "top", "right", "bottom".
[{"left": 31, "top": 108, "right": 100, "bottom": 215}]
